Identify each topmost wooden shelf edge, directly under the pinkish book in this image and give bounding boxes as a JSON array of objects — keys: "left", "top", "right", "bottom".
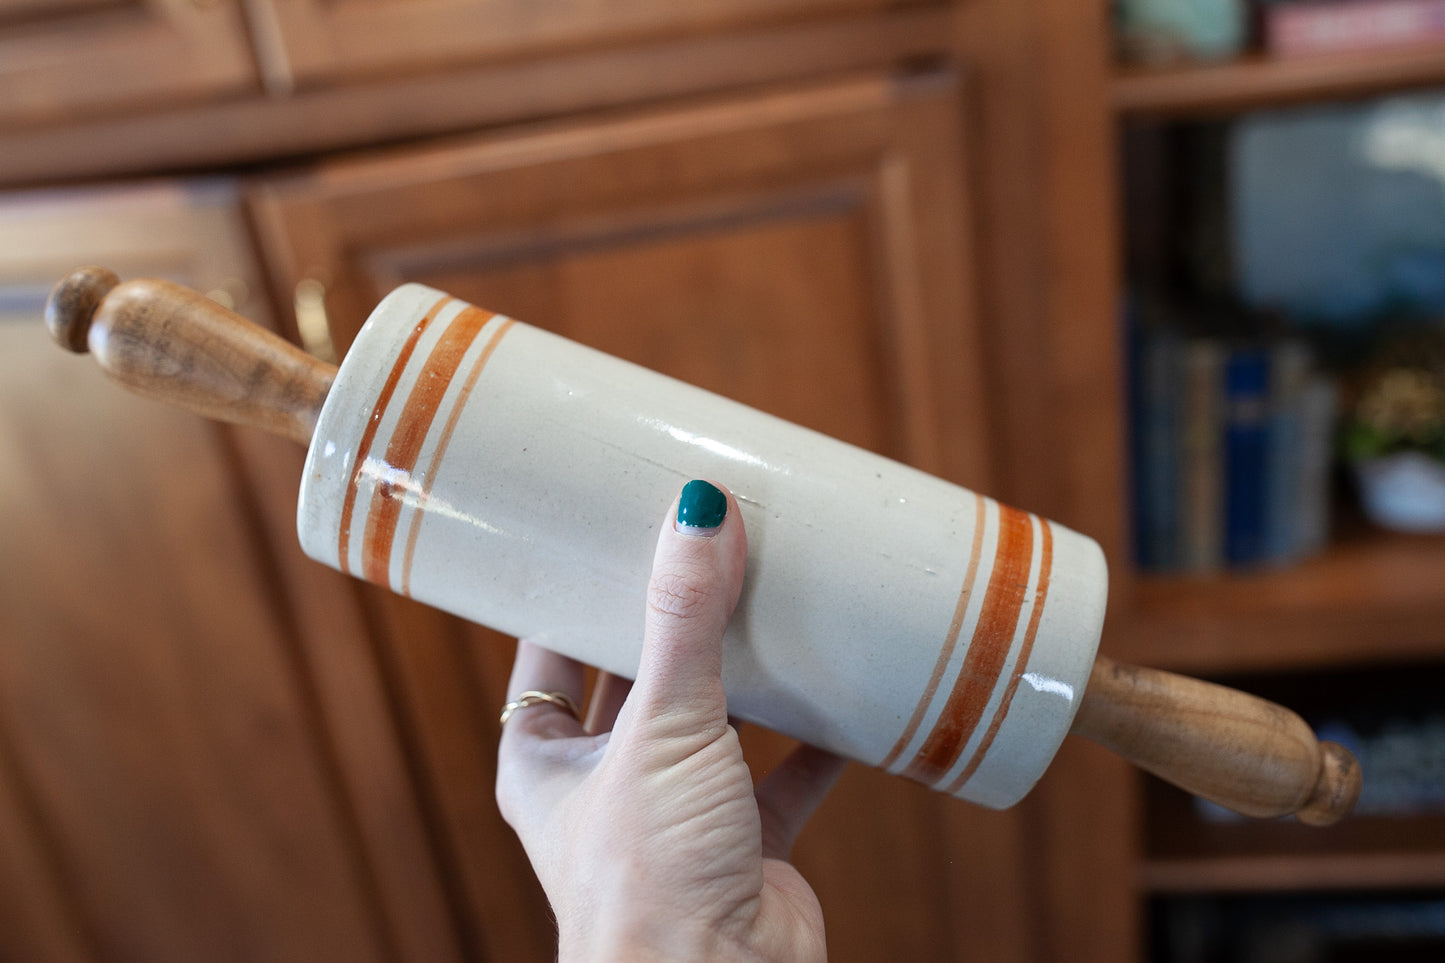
[{"left": 1111, "top": 43, "right": 1445, "bottom": 116}]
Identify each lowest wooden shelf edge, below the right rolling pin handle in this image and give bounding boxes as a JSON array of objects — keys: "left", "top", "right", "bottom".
[{"left": 1139, "top": 852, "right": 1445, "bottom": 895}]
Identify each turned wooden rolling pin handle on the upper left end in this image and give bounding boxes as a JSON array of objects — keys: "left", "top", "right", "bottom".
[{"left": 45, "top": 268, "right": 337, "bottom": 445}]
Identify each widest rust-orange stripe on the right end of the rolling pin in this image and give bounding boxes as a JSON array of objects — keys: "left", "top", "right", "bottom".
[{"left": 903, "top": 505, "right": 1033, "bottom": 784}]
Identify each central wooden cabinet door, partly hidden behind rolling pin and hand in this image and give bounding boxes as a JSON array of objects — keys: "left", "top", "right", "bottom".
[{"left": 256, "top": 75, "right": 1063, "bottom": 960}]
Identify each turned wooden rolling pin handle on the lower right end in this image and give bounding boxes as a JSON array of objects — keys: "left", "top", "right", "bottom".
[{"left": 1072, "top": 655, "right": 1360, "bottom": 826}]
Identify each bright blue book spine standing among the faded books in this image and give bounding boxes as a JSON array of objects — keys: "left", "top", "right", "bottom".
[{"left": 1224, "top": 347, "right": 1270, "bottom": 567}]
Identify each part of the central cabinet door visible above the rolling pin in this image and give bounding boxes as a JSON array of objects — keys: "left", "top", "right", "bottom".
[{"left": 254, "top": 74, "right": 988, "bottom": 489}]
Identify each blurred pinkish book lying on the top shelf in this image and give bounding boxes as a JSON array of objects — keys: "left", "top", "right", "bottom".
[{"left": 1263, "top": 0, "right": 1445, "bottom": 56}]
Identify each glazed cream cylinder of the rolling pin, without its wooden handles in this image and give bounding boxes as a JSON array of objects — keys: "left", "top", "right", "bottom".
[{"left": 298, "top": 285, "right": 1107, "bottom": 807}]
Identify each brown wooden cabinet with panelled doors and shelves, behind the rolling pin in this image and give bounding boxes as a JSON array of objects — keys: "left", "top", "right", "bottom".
[{"left": 22, "top": 0, "right": 1445, "bottom": 962}]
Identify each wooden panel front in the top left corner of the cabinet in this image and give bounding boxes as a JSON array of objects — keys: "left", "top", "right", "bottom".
[{"left": 0, "top": 0, "right": 257, "bottom": 126}]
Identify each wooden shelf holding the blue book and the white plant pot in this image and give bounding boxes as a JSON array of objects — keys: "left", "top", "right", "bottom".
[{"left": 1111, "top": 532, "right": 1445, "bottom": 674}]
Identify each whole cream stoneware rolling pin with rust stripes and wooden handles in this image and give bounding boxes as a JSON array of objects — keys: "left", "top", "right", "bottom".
[{"left": 46, "top": 268, "right": 1360, "bottom": 824}]
